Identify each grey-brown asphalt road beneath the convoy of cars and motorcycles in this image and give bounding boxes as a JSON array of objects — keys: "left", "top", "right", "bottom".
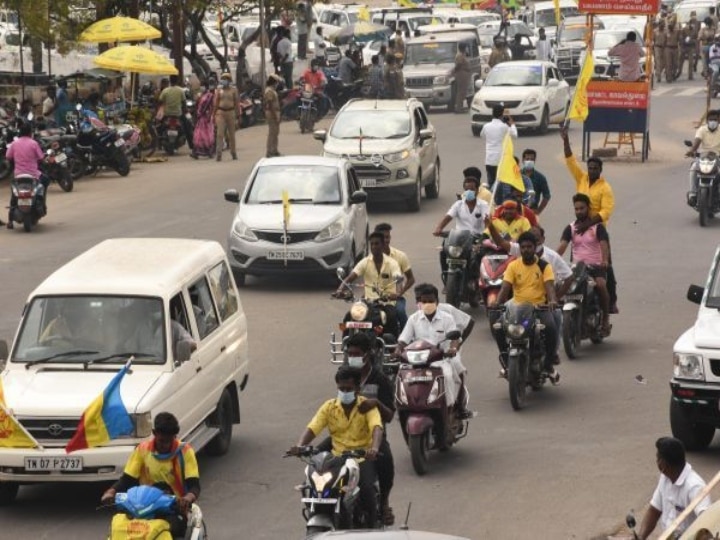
[{"left": 0, "top": 83, "right": 720, "bottom": 540}]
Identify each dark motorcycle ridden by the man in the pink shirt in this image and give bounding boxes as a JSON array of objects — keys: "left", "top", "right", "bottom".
[{"left": 562, "top": 262, "right": 604, "bottom": 359}]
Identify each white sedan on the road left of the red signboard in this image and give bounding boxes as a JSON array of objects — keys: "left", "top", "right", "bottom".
[{"left": 470, "top": 60, "right": 570, "bottom": 137}]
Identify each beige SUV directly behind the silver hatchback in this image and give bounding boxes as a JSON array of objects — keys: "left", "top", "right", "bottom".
[{"left": 315, "top": 98, "right": 440, "bottom": 212}]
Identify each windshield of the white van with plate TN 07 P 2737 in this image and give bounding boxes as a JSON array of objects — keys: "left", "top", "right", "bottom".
[{"left": 12, "top": 296, "right": 166, "bottom": 364}]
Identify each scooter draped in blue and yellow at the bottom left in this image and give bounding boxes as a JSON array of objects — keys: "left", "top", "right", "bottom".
[{"left": 108, "top": 486, "right": 207, "bottom": 540}]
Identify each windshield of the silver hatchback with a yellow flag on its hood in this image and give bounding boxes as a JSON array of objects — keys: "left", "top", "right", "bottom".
[{"left": 245, "top": 165, "right": 341, "bottom": 204}]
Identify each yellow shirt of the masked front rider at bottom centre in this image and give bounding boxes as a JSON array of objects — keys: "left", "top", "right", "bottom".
[{"left": 307, "top": 397, "right": 383, "bottom": 456}]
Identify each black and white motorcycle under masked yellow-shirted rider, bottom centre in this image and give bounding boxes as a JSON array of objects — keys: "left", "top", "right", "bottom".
[{"left": 285, "top": 446, "right": 382, "bottom": 536}]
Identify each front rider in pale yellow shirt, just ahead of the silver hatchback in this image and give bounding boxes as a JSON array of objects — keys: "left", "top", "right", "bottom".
[{"left": 333, "top": 232, "right": 402, "bottom": 336}]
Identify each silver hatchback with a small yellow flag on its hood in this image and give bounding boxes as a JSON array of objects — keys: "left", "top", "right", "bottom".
[{"left": 225, "top": 156, "right": 369, "bottom": 286}]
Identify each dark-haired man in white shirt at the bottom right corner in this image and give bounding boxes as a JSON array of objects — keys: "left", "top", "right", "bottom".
[{"left": 637, "top": 437, "right": 711, "bottom": 540}]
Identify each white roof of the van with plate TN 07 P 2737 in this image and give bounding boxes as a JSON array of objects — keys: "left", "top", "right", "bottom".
[{"left": 32, "top": 238, "right": 225, "bottom": 296}]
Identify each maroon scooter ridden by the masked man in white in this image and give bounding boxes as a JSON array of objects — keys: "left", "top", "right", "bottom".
[{"left": 395, "top": 330, "right": 469, "bottom": 475}]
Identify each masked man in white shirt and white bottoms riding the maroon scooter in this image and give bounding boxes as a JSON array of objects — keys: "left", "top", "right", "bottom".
[{"left": 395, "top": 283, "right": 473, "bottom": 419}]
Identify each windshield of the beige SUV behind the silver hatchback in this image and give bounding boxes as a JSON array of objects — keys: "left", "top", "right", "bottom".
[{"left": 330, "top": 110, "right": 410, "bottom": 139}]
